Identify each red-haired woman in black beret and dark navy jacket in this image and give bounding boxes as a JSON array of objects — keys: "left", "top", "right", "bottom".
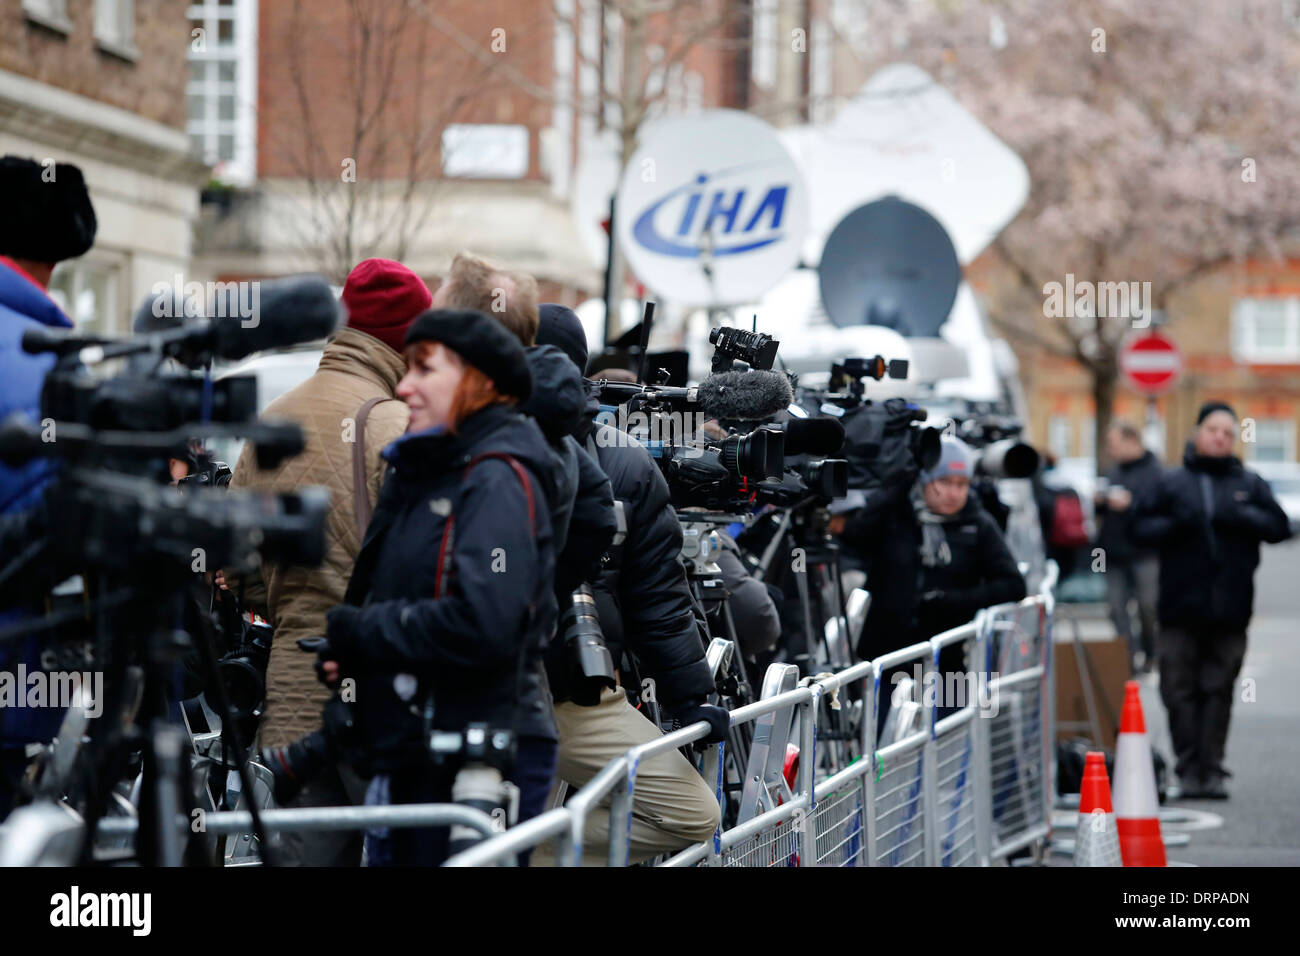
[{"left": 320, "top": 310, "right": 556, "bottom": 865}]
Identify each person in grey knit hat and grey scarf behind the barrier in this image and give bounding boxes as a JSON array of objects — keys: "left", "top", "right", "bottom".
[{"left": 832, "top": 436, "right": 1026, "bottom": 715}]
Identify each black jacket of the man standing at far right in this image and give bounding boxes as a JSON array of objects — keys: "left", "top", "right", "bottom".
[{"left": 1134, "top": 442, "right": 1291, "bottom": 631}]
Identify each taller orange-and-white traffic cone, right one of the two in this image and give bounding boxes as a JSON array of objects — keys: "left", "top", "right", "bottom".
[{"left": 1115, "top": 680, "right": 1166, "bottom": 866}]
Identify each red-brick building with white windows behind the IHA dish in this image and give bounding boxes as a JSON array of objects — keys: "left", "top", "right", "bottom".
[{"left": 189, "top": 0, "right": 861, "bottom": 304}]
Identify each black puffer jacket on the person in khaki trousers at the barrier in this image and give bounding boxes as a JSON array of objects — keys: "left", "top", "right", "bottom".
[{"left": 569, "top": 420, "right": 714, "bottom": 708}]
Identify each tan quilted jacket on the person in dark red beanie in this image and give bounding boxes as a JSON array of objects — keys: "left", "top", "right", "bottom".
[{"left": 228, "top": 329, "right": 408, "bottom": 747}]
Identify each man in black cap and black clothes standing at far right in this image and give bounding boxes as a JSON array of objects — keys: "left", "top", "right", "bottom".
[{"left": 1134, "top": 402, "right": 1290, "bottom": 800}]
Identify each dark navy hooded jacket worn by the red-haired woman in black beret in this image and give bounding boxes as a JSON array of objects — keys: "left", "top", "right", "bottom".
[{"left": 328, "top": 405, "right": 556, "bottom": 773}]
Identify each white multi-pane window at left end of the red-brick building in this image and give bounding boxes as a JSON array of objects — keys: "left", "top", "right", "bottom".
[{"left": 186, "top": 0, "right": 257, "bottom": 186}]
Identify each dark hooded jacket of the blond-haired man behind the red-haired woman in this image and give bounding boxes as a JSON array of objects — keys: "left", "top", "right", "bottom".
[{"left": 521, "top": 345, "right": 618, "bottom": 595}]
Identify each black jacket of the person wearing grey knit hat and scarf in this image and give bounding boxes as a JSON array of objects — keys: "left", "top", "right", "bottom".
[{"left": 842, "top": 489, "right": 1026, "bottom": 659}]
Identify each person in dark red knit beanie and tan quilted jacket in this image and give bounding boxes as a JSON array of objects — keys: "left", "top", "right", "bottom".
[{"left": 228, "top": 259, "right": 432, "bottom": 866}]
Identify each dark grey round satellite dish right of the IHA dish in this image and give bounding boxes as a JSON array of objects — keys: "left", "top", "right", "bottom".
[{"left": 818, "top": 196, "right": 962, "bottom": 338}]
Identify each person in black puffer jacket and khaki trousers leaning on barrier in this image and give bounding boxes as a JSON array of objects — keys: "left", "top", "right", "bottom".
[{"left": 537, "top": 304, "right": 729, "bottom": 862}]
